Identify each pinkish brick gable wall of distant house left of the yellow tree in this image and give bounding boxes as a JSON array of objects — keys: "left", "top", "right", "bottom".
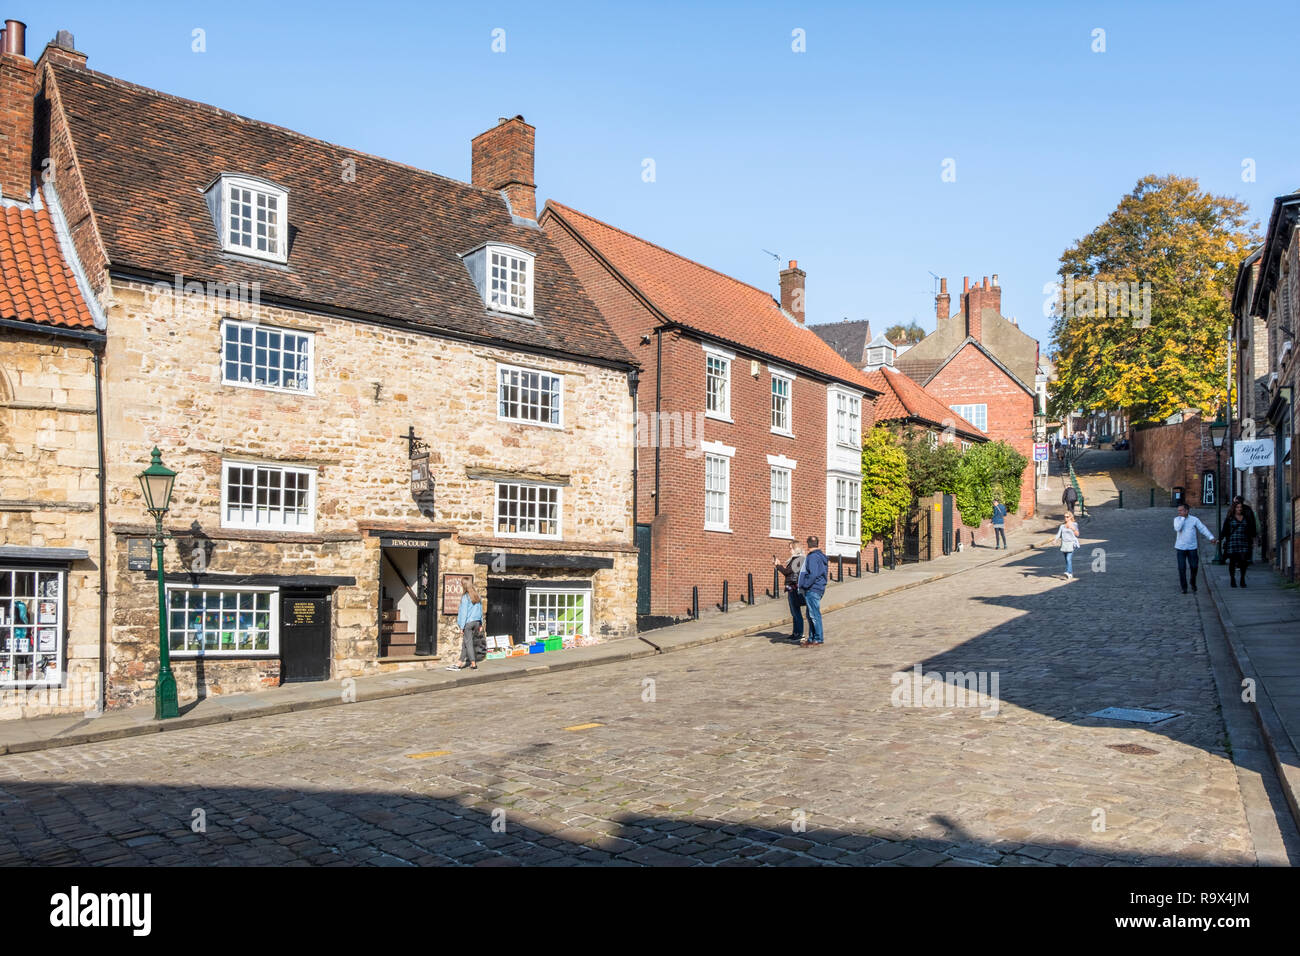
[{"left": 926, "top": 345, "right": 1035, "bottom": 518}]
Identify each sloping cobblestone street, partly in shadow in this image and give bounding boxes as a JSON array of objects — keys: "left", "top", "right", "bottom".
[{"left": 0, "top": 509, "right": 1284, "bottom": 866}]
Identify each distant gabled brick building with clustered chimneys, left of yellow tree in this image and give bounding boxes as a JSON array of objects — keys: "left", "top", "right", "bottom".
[{"left": 897, "top": 274, "right": 1039, "bottom": 518}]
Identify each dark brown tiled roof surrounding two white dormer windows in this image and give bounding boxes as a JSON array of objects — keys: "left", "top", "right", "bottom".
[{"left": 52, "top": 64, "right": 634, "bottom": 364}]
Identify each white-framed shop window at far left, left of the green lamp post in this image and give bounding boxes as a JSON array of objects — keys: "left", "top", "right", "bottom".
[{"left": 0, "top": 567, "right": 66, "bottom": 687}]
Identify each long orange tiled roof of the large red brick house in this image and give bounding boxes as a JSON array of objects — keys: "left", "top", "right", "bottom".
[{"left": 543, "top": 200, "right": 871, "bottom": 392}]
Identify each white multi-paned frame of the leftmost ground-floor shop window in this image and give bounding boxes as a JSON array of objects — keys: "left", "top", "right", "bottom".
[{"left": 0, "top": 564, "right": 68, "bottom": 687}]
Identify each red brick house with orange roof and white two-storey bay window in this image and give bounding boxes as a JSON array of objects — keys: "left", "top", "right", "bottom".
[{"left": 541, "top": 202, "right": 878, "bottom": 622}]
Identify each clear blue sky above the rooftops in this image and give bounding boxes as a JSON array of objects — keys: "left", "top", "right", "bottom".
[{"left": 30, "top": 0, "right": 1300, "bottom": 347}]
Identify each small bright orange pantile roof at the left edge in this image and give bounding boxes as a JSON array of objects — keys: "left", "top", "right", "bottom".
[{"left": 0, "top": 206, "right": 95, "bottom": 329}]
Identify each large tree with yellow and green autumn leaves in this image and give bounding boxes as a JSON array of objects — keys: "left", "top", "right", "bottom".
[{"left": 1052, "top": 176, "right": 1260, "bottom": 423}]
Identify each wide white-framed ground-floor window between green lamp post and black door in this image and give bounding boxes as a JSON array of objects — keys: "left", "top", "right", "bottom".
[{"left": 168, "top": 587, "right": 280, "bottom": 657}]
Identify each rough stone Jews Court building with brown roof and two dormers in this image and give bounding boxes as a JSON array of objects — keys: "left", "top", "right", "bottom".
[{"left": 22, "top": 35, "right": 637, "bottom": 706}]
